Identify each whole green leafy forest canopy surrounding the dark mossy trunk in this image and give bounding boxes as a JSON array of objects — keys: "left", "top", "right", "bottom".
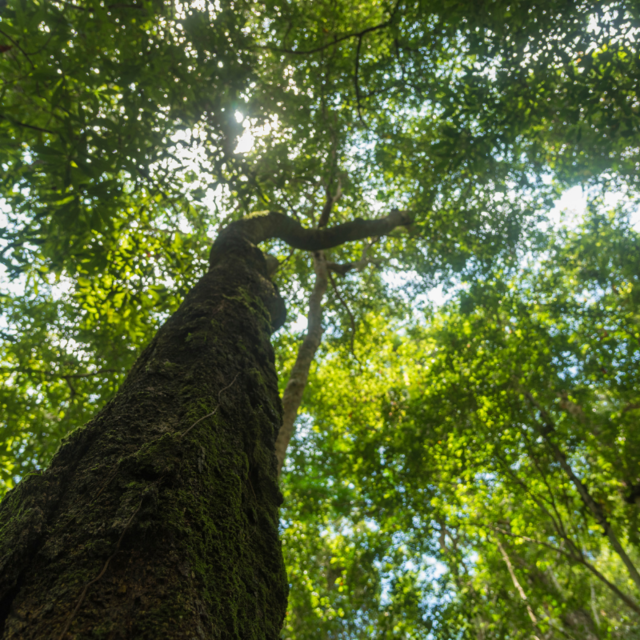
[{"left": 0, "top": 0, "right": 640, "bottom": 640}]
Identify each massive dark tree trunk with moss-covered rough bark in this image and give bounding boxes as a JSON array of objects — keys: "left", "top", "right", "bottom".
[{"left": 0, "top": 234, "right": 288, "bottom": 640}]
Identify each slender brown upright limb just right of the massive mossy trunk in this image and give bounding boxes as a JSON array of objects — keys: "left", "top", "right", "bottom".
[{"left": 276, "top": 251, "right": 327, "bottom": 475}]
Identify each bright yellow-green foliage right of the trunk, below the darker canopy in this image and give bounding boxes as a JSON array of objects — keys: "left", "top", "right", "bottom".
[{"left": 285, "top": 208, "right": 640, "bottom": 638}]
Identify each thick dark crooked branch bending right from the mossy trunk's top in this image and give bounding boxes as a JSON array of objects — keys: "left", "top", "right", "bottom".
[{"left": 211, "top": 209, "right": 411, "bottom": 264}]
